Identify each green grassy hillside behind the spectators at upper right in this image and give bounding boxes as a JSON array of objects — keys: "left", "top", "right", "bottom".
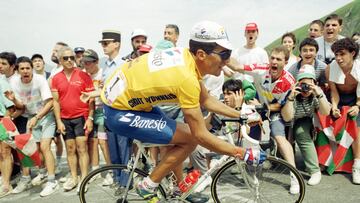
[{"left": 265, "top": 0, "right": 360, "bottom": 55}]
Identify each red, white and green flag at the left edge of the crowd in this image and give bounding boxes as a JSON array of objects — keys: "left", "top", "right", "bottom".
[{"left": 0, "top": 118, "right": 41, "bottom": 167}]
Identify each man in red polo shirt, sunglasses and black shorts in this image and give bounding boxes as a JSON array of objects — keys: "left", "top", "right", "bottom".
[{"left": 51, "top": 47, "right": 94, "bottom": 191}]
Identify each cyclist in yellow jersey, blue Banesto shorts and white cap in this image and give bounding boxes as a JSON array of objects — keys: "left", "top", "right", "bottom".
[{"left": 83, "top": 21, "right": 265, "bottom": 201}]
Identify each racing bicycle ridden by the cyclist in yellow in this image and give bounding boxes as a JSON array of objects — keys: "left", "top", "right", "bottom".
[{"left": 79, "top": 105, "right": 305, "bottom": 203}]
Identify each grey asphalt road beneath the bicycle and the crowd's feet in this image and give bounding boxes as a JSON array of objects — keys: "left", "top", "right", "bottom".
[{"left": 0, "top": 144, "right": 360, "bottom": 203}]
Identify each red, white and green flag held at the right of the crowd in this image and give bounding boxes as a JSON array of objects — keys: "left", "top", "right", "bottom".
[{"left": 314, "top": 106, "right": 357, "bottom": 175}]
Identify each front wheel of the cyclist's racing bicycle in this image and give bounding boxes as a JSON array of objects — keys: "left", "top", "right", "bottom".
[{"left": 211, "top": 156, "right": 305, "bottom": 203}]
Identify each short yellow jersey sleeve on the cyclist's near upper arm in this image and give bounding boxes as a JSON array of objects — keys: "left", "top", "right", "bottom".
[{"left": 177, "top": 77, "right": 201, "bottom": 109}]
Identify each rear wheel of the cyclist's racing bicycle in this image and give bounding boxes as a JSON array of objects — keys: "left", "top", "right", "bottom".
[{"left": 79, "top": 164, "right": 166, "bottom": 203}]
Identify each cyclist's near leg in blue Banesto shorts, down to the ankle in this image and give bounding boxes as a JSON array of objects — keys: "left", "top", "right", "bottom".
[{"left": 104, "top": 106, "right": 197, "bottom": 183}]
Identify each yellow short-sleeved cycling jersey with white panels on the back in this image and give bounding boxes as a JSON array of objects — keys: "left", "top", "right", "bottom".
[{"left": 101, "top": 47, "right": 201, "bottom": 111}]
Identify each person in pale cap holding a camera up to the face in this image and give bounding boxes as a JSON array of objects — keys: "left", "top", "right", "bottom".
[{"left": 281, "top": 64, "right": 331, "bottom": 185}]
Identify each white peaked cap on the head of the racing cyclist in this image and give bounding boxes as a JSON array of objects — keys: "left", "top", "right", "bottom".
[{"left": 190, "top": 21, "right": 233, "bottom": 50}]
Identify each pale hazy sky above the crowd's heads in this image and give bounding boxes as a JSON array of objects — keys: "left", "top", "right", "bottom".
[{"left": 0, "top": 0, "right": 351, "bottom": 65}]
